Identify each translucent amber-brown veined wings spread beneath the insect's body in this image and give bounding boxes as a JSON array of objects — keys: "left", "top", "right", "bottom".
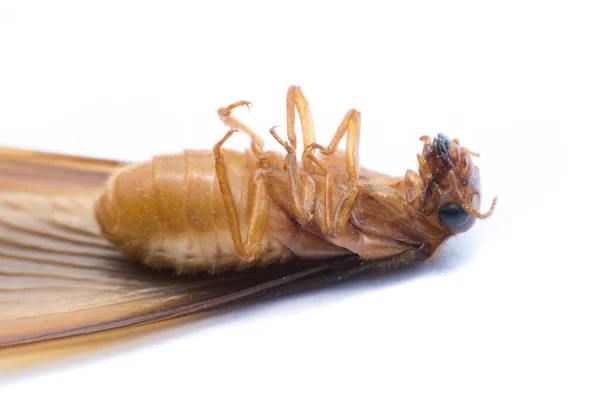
[{"left": 0, "top": 148, "right": 371, "bottom": 347}]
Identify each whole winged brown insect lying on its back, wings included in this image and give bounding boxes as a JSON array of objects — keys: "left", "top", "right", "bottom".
[{"left": 0, "top": 87, "right": 496, "bottom": 347}]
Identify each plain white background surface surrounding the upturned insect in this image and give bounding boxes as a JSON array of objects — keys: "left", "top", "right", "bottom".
[{"left": 0, "top": 0, "right": 600, "bottom": 399}]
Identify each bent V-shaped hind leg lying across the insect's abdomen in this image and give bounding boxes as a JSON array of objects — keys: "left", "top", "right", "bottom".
[{"left": 213, "top": 129, "right": 269, "bottom": 262}]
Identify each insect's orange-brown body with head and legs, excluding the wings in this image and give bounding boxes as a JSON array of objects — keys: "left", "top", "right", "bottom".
[{"left": 96, "top": 86, "right": 496, "bottom": 273}]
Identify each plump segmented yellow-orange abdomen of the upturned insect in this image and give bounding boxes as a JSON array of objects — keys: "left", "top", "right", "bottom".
[{"left": 96, "top": 150, "right": 290, "bottom": 272}]
